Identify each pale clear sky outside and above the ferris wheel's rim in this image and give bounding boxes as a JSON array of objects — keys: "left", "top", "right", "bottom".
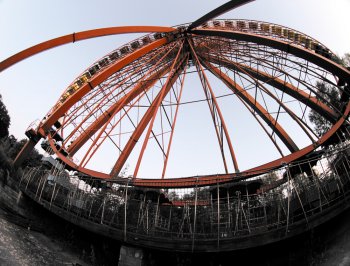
[{"left": 0, "top": 0, "right": 350, "bottom": 179}]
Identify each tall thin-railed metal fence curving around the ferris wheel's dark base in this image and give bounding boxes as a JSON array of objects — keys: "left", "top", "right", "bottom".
[{"left": 20, "top": 145, "right": 350, "bottom": 249}]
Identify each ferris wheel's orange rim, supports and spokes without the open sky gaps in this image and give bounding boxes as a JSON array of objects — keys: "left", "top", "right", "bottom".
[{"left": 0, "top": 1, "right": 350, "bottom": 188}]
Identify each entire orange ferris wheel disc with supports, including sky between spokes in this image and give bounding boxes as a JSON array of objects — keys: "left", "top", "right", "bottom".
[{"left": 0, "top": 1, "right": 350, "bottom": 187}]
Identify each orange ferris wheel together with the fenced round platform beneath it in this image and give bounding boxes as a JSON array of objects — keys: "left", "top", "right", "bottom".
[{"left": 0, "top": 0, "right": 350, "bottom": 251}]
